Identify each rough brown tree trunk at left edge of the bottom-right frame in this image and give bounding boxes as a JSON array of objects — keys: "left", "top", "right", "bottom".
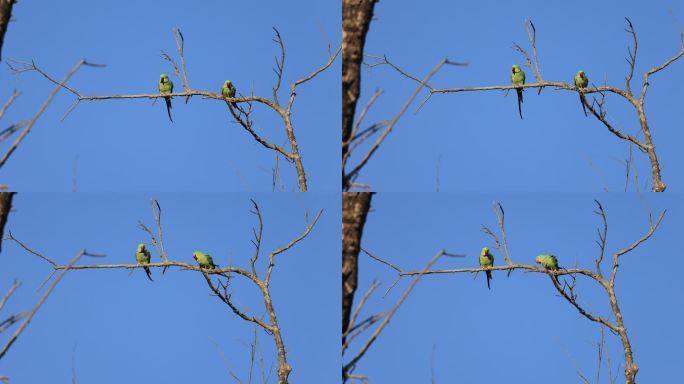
[{"left": 342, "top": 192, "right": 372, "bottom": 344}]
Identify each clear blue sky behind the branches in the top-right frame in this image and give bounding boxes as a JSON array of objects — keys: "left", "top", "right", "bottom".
[{"left": 352, "top": 0, "right": 684, "bottom": 192}]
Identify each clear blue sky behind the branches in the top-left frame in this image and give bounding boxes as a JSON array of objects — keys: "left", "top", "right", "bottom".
[{"left": 0, "top": 1, "right": 341, "bottom": 192}]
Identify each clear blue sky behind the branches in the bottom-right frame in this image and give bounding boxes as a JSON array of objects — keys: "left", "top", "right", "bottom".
[{"left": 352, "top": 193, "right": 684, "bottom": 383}]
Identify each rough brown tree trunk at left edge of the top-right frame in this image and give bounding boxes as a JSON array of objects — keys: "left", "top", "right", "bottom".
[{"left": 342, "top": 0, "right": 377, "bottom": 187}]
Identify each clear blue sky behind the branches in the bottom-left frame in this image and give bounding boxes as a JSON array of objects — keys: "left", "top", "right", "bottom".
[{"left": 0, "top": 193, "right": 340, "bottom": 383}]
